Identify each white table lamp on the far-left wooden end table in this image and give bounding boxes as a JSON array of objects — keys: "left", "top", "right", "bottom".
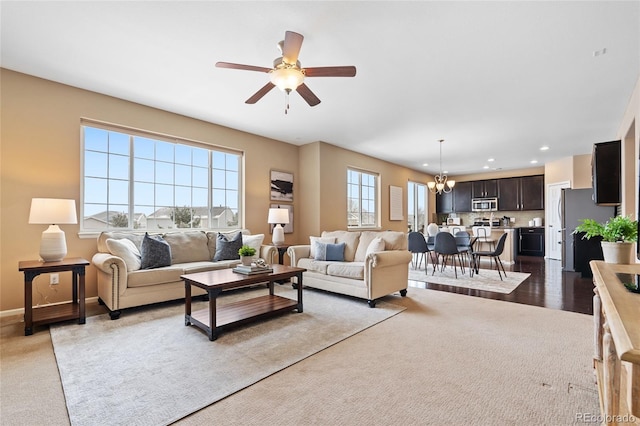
[{"left": 29, "top": 198, "right": 78, "bottom": 262}]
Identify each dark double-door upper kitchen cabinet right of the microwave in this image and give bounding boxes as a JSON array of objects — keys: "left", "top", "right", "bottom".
[{"left": 498, "top": 175, "right": 544, "bottom": 211}]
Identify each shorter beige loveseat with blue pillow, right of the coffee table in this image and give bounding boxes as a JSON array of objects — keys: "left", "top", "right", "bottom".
[{"left": 287, "top": 231, "right": 411, "bottom": 308}]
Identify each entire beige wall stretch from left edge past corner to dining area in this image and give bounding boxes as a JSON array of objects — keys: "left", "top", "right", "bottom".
[{"left": 0, "top": 69, "right": 430, "bottom": 311}]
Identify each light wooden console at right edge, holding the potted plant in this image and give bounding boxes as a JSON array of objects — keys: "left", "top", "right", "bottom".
[{"left": 590, "top": 260, "right": 640, "bottom": 425}]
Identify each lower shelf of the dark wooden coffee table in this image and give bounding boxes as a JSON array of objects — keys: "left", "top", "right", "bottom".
[{"left": 185, "top": 295, "right": 298, "bottom": 340}]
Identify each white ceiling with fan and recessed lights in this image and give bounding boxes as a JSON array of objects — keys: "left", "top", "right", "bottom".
[{"left": 0, "top": 1, "right": 640, "bottom": 174}]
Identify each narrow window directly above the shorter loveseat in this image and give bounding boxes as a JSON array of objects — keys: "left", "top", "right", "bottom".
[{"left": 347, "top": 169, "right": 378, "bottom": 228}]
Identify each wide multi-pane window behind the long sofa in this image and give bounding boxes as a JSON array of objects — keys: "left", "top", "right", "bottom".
[{"left": 81, "top": 121, "right": 242, "bottom": 231}]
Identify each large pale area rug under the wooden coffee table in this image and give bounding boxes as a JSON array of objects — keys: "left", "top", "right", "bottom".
[{"left": 51, "top": 286, "right": 405, "bottom": 425}]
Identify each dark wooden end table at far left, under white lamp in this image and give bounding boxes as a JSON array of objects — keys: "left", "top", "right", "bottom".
[{"left": 18, "top": 257, "right": 89, "bottom": 336}]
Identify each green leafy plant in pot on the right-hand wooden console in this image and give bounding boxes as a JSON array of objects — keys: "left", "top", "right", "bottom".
[{"left": 573, "top": 216, "right": 638, "bottom": 264}]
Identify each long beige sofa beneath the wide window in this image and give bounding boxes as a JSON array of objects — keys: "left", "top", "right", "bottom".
[{"left": 92, "top": 230, "right": 277, "bottom": 319}]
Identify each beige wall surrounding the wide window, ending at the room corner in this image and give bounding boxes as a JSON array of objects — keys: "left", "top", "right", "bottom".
[{"left": 0, "top": 69, "right": 301, "bottom": 311}]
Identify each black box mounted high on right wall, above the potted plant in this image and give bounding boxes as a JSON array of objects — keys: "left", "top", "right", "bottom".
[{"left": 591, "top": 141, "right": 622, "bottom": 206}]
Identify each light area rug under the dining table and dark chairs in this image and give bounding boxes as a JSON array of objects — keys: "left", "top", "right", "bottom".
[{"left": 409, "top": 265, "right": 531, "bottom": 294}]
